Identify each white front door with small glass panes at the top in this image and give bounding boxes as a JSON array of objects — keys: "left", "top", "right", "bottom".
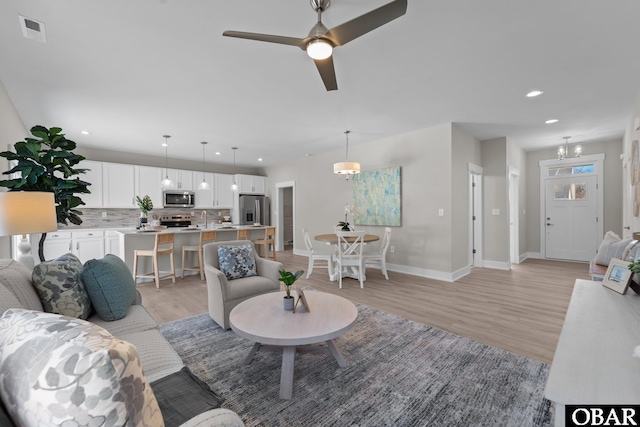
[{"left": 544, "top": 175, "right": 598, "bottom": 261}]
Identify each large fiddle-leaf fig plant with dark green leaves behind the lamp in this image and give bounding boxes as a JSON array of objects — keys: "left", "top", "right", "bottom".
[{"left": 0, "top": 126, "right": 91, "bottom": 261}]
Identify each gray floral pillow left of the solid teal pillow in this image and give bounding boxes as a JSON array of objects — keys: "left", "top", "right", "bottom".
[{"left": 31, "top": 254, "right": 91, "bottom": 319}]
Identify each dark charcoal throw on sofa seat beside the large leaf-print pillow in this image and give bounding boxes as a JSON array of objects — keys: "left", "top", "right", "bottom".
[{"left": 151, "top": 366, "right": 224, "bottom": 427}]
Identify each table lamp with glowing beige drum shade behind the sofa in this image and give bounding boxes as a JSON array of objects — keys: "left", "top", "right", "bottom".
[{"left": 0, "top": 191, "right": 58, "bottom": 270}]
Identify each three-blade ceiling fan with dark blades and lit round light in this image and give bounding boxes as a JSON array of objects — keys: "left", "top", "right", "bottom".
[{"left": 222, "top": 0, "right": 407, "bottom": 91}]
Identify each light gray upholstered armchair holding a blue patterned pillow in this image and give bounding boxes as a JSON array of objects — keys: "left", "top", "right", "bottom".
[{"left": 202, "top": 240, "right": 283, "bottom": 329}]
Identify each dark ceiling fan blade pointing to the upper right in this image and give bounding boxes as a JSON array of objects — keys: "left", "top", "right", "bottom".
[{"left": 325, "top": 0, "right": 407, "bottom": 46}]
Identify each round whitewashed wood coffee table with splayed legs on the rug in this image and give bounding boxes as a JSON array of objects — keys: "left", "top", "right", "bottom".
[{"left": 229, "top": 291, "right": 358, "bottom": 399}]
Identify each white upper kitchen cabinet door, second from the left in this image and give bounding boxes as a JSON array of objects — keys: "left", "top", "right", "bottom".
[{"left": 102, "top": 163, "right": 137, "bottom": 208}]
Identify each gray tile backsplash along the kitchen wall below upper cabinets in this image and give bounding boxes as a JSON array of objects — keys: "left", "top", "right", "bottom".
[{"left": 58, "top": 207, "right": 230, "bottom": 230}]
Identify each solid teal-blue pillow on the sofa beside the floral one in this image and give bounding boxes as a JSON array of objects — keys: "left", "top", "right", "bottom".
[{"left": 82, "top": 254, "right": 136, "bottom": 322}]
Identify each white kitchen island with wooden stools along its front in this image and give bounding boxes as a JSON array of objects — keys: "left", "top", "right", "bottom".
[{"left": 117, "top": 225, "right": 267, "bottom": 281}]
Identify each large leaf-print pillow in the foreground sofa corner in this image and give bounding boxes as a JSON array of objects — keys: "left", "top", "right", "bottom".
[{"left": 0, "top": 309, "right": 164, "bottom": 427}]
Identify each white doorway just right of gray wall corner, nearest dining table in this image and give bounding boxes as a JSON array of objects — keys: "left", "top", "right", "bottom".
[{"left": 467, "top": 163, "right": 484, "bottom": 267}]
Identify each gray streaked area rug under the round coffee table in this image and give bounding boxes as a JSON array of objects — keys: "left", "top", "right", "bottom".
[{"left": 160, "top": 305, "right": 552, "bottom": 427}]
